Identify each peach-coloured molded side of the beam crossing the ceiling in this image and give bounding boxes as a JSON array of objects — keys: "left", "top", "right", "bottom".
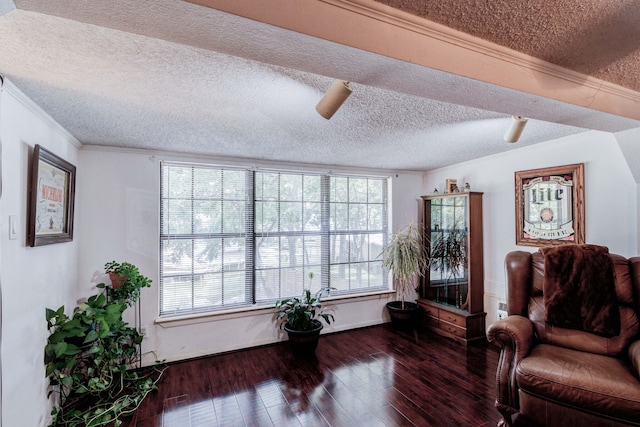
[{"left": 189, "top": 0, "right": 640, "bottom": 121}]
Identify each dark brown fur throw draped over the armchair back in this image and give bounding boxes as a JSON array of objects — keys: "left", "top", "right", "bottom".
[{"left": 540, "top": 244, "right": 620, "bottom": 337}]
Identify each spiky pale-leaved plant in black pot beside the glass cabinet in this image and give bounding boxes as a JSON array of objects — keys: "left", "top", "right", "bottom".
[{"left": 381, "top": 222, "right": 429, "bottom": 327}]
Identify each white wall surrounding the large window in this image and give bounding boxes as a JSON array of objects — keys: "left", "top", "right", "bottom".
[{"left": 77, "top": 147, "right": 422, "bottom": 363}]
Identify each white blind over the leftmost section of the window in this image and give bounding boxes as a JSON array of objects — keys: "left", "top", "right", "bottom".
[{"left": 160, "top": 163, "right": 253, "bottom": 315}]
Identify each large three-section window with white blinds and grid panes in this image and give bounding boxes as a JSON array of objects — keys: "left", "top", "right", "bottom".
[{"left": 160, "top": 162, "right": 387, "bottom": 316}]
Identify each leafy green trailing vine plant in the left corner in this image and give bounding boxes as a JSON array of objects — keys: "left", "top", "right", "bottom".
[{"left": 44, "top": 261, "right": 164, "bottom": 427}]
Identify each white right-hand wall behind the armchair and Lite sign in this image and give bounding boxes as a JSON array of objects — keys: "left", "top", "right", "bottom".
[{"left": 423, "top": 130, "right": 638, "bottom": 325}]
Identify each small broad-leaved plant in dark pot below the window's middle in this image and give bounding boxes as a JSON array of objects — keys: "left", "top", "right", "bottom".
[{"left": 275, "top": 272, "right": 335, "bottom": 356}]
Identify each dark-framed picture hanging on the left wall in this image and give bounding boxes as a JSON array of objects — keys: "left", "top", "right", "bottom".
[{"left": 27, "top": 145, "right": 76, "bottom": 246}]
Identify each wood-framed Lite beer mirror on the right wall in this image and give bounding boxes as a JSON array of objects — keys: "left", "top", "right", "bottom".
[{"left": 515, "top": 163, "right": 585, "bottom": 246}]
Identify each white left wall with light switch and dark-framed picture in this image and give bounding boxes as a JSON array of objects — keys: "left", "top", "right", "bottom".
[{"left": 0, "top": 80, "right": 81, "bottom": 427}]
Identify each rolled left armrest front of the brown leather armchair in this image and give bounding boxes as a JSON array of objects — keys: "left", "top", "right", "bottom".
[{"left": 487, "top": 315, "right": 533, "bottom": 426}]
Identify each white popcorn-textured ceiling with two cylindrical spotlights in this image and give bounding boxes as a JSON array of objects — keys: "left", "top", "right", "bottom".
[{"left": 0, "top": 0, "right": 640, "bottom": 170}]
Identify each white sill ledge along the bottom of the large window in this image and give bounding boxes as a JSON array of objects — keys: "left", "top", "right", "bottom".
[{"left": 154, "top": 290, "right": 396, "bottom": 328}]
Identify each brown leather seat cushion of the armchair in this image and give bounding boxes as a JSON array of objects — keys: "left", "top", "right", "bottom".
[{"left": 516, "top": 344, "right": 640, "bottom": 420}]
